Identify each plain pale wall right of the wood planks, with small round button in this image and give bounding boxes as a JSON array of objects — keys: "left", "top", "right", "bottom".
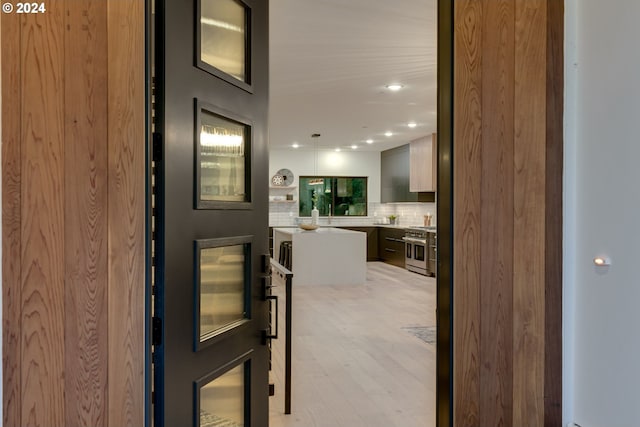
[{"left": 564, "top": 0, "right": 640, "bottom": 427}]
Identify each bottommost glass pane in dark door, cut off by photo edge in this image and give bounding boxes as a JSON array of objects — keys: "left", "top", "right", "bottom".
[{"left": 200, "top": 364, "right": 245, "bottom": 427}]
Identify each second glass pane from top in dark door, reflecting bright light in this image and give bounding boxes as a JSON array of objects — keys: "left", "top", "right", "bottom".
[{"left": 199, "top": 110, "right": 248, "bottom": 202}]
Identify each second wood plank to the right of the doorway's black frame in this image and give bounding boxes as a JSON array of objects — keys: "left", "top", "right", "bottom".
[{"left": 479, "top": 0, "right": 515, "bottom": 426}]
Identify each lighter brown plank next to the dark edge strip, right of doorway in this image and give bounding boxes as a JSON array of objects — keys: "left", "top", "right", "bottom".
[{"left": 513, "top": 0, "right": 547, "bottom": 426}]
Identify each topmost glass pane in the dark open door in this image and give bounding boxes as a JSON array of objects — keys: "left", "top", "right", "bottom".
[{"left": 200, "top": 0, "right": 247, "bottom": 82}]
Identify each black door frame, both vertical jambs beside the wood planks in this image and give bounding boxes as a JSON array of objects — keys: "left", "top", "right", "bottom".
[{"left": 145, "top": 0, "right": 454, "bottom": 427}]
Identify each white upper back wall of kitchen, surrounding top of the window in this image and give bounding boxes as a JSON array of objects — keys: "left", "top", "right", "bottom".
[{"left": 269, "top": 148, "right": 380, "bottom": 202}]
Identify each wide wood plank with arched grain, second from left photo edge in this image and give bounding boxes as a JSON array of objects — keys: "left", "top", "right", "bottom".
[{"left": 21, "top": 2, "right": 65, "bottom": 426}]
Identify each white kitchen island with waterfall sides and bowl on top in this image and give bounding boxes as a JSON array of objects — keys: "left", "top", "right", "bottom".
[{"left": 273, "top": 227, "right": 367, "bottom": 286}]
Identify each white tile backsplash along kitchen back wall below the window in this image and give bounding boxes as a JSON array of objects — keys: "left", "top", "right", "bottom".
[{"left": 269, "top": 201, "right": 436, "bottom": 227}]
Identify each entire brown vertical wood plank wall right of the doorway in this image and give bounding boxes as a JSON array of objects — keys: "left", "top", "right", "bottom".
[{"left": 453, "top": 0, "right": 563, "bottom": 427}]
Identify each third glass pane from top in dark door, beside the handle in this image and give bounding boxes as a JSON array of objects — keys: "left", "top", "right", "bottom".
[{"left": 200, "top": 245, "right": 246, "bottom": 342}]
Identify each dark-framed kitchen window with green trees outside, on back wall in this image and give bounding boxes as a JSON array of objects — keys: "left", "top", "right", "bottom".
[{"left": 299, "top": 176, "right": 368, "bottom": 216}]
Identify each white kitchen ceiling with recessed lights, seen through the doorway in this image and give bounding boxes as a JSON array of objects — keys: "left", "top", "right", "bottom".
[{"left": 269, "top": 0, "right": 437, "bottom": 151}]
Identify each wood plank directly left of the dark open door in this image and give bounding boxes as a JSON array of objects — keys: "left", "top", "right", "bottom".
[{"left": 108, "top": 1, "right": 146, "bottom": 427}]
